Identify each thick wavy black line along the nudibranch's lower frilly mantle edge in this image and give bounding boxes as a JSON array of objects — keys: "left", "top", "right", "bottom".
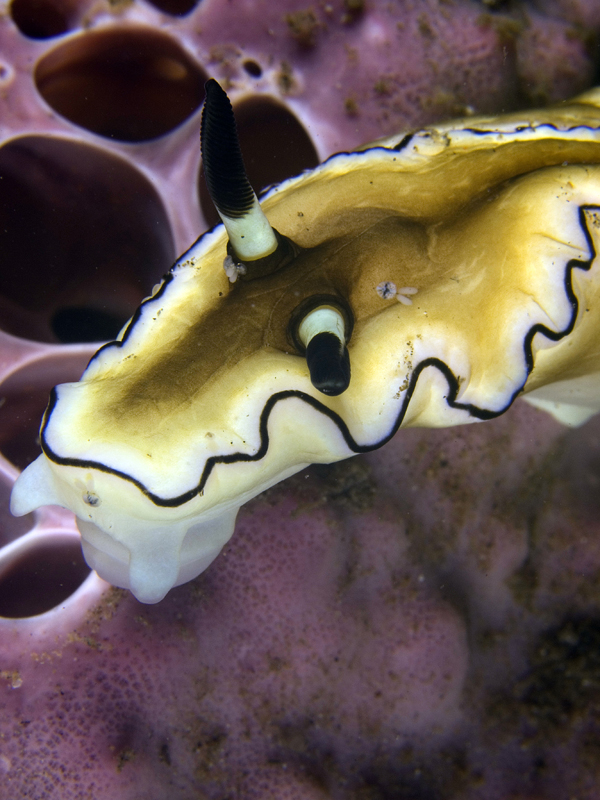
[{"left": 40, "top": 205, "right": 600, "bottom": 508}]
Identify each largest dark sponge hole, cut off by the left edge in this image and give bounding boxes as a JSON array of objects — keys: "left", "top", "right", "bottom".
[{"left": 0, "top": 136, "right": 175, "bottom": 342}]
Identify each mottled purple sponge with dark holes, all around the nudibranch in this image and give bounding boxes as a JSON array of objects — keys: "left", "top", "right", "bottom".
[{"left": 0, "top": 0, "right": 600, "bottom": 800}]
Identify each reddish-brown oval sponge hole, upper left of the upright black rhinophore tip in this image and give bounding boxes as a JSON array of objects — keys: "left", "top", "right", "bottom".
[{"left": 34, "top": 29, "right": 207, "bottom": 142}]
